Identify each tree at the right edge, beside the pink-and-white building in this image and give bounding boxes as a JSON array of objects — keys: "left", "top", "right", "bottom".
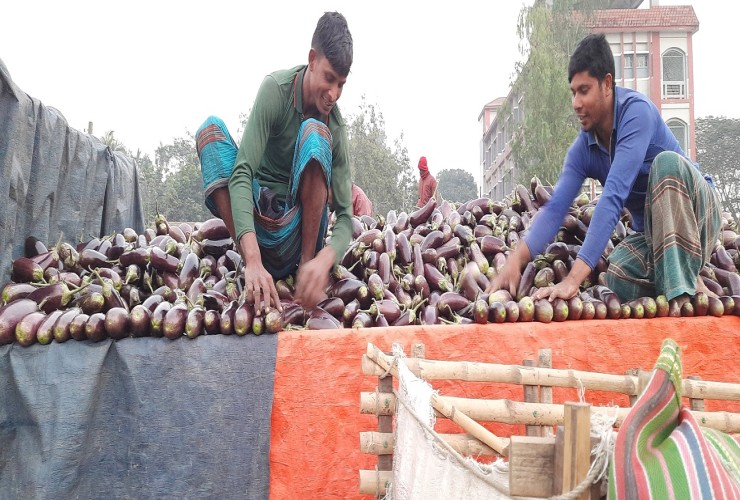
[{"left": 696, "top": 116, "right": 740, "bottom": 221}]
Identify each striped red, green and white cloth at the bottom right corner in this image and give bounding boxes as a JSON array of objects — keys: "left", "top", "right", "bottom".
[{"left": 609, "top": 339, "right": 740, "bottom": 499}]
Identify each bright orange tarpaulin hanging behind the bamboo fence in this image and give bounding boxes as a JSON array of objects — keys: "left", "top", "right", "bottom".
[{"left": 270, "top": 316, "right": 740, "bottom": 499}]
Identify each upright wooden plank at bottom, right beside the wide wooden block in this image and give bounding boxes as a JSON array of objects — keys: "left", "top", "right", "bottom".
[{"left": 562, "top": 403, "right": 591, "bottom": 500}]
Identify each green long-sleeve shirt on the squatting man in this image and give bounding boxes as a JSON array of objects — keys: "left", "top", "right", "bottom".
[{"left": 229, "top": 65, "right": 352, "bottom": 270}]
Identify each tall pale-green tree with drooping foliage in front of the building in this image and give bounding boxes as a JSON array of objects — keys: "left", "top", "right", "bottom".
[{"left": 502, "top": 0, "right": 603, "bottom": 188}]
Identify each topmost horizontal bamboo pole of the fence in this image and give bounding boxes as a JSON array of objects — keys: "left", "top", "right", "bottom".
[{"left": 362, "top": 356, "right": 740, "bottom": 401}]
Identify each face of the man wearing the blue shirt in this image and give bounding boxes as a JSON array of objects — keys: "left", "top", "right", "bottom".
[{"left": 570, "top": 71, "right": 612, "bottom": 132}]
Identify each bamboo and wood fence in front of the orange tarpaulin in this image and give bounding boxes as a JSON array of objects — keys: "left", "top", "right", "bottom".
[{"left": 360, "top": 343, "right": 740, "bottom": 498}]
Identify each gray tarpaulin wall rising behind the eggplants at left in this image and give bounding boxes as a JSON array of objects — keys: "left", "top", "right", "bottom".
[{"left": 0, "top": 56, "right": 144, "bottom": 283}]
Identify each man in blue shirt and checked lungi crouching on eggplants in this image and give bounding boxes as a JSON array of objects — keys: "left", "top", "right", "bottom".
[{"left": 488, "top": 34, "right": 721, "bottom": 309}]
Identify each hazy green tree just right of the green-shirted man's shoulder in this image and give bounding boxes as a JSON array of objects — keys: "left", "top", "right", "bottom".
[{"left": 347, "top": 97, "right": 417, "bottom": 215}]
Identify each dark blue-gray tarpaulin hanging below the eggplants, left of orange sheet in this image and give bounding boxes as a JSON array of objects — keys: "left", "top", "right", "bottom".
[{"left": 0, "top": 335, "right": 277, "bottom": 499}]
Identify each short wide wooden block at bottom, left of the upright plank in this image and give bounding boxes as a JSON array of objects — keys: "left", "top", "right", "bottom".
[{"left": 509, "top": 436, "right": 555, "bottom": 498}]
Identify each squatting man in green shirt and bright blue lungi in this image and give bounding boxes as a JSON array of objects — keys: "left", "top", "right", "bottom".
[{"left": 196, "top": 12, "right": 352, "bottom": 314}]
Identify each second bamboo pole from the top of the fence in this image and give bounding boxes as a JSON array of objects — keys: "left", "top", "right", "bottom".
[{"left": 360, "top": 392, "right": 740, "bottom": 433}]
